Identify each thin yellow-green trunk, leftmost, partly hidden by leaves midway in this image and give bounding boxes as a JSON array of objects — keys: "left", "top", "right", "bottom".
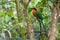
[{"left": 15, "top": 0, "right": 26, "bottom": 40}]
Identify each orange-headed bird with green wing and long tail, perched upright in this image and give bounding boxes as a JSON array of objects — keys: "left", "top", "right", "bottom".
[{"left": 32, "top": 8, "right": 44, "bottom": 30}]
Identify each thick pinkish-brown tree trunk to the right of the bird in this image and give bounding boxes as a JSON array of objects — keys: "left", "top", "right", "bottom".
[{"left": 48, "top": 0, "right": 58, "bottom": 40}]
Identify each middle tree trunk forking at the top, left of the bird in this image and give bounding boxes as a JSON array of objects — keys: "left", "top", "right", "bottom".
[{"left": 20, "top": 0, "right": 34, "bottom": 40}]
